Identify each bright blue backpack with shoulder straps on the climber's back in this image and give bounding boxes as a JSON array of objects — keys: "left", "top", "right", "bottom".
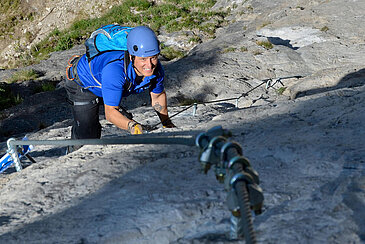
[{"left": 85, "top": 24, "right": 133, "bottom": 90}]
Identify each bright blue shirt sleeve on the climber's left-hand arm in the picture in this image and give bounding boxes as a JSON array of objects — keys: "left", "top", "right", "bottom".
[{"left": 101, "top": 62, "right": 125, "bottom": 106}]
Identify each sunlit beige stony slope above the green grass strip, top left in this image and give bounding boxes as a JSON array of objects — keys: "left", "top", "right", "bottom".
[{"left": 0, "top": 0, "right": 122, "bottom": 67}]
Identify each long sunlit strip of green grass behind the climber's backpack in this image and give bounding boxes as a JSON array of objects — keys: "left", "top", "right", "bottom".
[{"left": 17, "top": 0, "right": 226, "bottom": 65}]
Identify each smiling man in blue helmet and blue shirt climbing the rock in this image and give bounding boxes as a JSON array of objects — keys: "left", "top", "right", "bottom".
[{"left": 66, "top": 26, "right": 175, "bottom": 147}]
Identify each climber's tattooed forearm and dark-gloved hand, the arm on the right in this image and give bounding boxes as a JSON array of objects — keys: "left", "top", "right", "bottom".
[{"left": 150, "top": 91, "right": 175, "bottom": 128}]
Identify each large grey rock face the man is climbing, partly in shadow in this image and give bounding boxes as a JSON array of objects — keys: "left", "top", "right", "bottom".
[{"left": 0, "top": 0, "right": 365, "bottom": 243}]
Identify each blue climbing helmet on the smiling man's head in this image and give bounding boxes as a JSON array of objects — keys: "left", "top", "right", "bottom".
[{"left": 127, "top": 26, "right": 160, "bottom": 57}]
